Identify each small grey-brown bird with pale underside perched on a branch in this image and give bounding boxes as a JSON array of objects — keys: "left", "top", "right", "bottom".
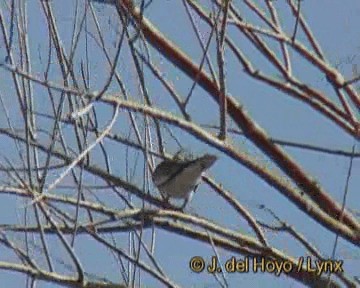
[{"left": 153, "top": 154, "right": 217, "bottom": 209}]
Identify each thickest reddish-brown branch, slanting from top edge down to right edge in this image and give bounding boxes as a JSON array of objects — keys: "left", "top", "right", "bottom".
[{"left": 116, "top": 0, "right": 360, "bottom": 236}]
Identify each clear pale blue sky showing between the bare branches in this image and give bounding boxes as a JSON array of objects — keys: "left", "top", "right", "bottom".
[{"left": 0, "top": 0, "right": 360, "bottom": 287}]
